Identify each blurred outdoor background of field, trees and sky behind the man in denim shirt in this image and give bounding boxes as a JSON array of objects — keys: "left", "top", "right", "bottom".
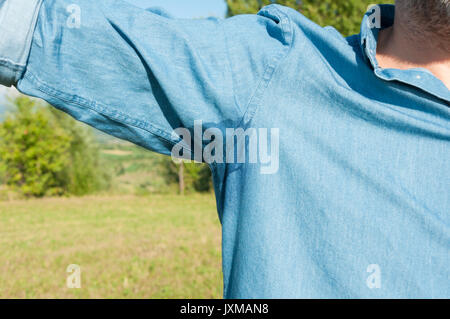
[{"left": 0, "top": 0, "right": 393, "bottom": 298}]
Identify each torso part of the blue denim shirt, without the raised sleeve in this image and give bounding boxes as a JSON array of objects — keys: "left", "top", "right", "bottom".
[{"left": 219, "top": 7, "right": 450, "bottom": 298}]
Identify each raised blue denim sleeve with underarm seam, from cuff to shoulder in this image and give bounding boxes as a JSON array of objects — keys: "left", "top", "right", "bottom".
[{"left": 0, "top": 0, "right": 288, "bottom": 158}]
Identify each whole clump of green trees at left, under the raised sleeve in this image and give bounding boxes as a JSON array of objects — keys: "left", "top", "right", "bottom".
[{"left": 0, "top": 96, "right": 110, "bottom": 197}]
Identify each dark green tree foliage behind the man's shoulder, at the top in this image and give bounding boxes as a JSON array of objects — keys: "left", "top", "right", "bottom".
[{"left": 227, "top": 0, "right": 394, "bottom": 36}]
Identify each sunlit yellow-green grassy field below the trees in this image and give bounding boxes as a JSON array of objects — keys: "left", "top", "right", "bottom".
[{"left": 0, "top": 194, "right": 222, "bottom": 298}]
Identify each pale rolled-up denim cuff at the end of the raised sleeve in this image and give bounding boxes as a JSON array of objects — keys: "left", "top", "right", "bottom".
[{"left": 0, "top": 0, "right": 43, "bottom": 86}]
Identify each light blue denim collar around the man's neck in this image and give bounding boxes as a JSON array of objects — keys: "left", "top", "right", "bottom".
[{"left": 360, "top": 4, "right": 450, "bottom": 102}]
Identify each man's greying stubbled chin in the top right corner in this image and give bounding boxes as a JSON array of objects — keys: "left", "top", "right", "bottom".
[{"left": 395, "top": 0, "right": 450, "bottom": 48}]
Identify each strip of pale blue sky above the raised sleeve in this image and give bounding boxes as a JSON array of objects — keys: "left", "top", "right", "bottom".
[{"left": 126, "top": 0, "right": 226, "bottom": 18}]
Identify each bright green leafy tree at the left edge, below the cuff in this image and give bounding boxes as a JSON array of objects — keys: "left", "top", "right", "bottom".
[{"left": 0, "top": 97, "right": 71, "bottom": 196}]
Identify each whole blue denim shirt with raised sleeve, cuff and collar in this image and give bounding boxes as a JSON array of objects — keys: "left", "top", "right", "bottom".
[{"left": 0, "top": 0, "right": 450, "bottom": 298}]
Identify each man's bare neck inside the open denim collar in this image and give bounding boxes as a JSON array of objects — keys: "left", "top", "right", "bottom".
[{"left": 377, "top": 16, "right": 450, "bottom": 89}]
